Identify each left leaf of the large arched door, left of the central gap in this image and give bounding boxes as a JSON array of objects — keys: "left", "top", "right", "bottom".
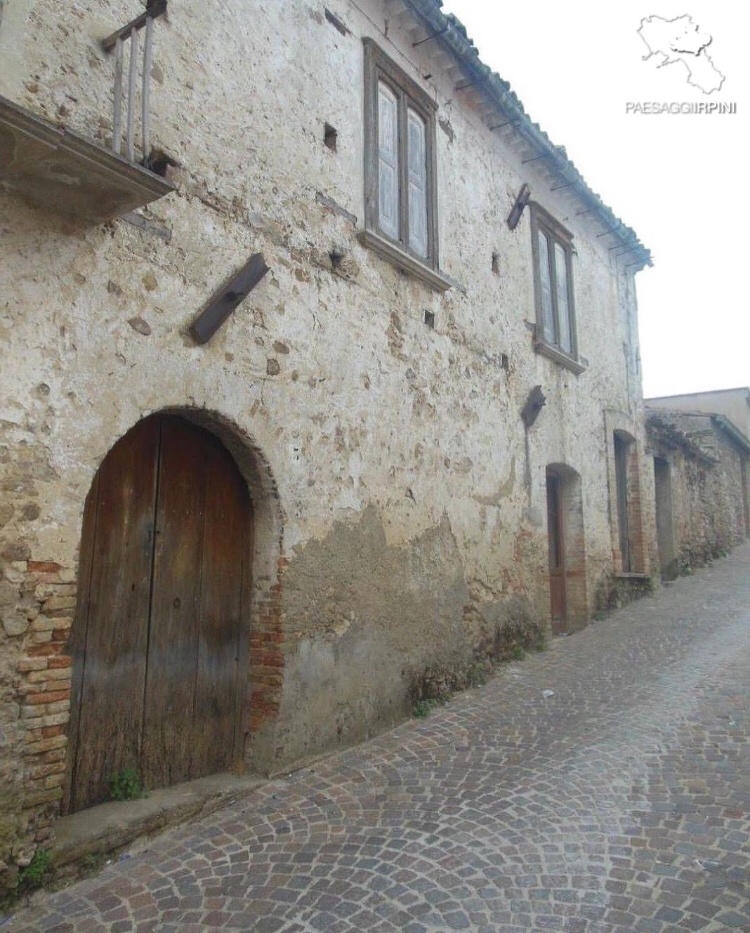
[{"left": 69, "top": 419, "right": 159, "bottom": 810}]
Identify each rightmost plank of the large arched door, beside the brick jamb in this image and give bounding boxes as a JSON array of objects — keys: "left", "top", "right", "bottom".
[{"left": 191, "top": 438, "right": 252, "bottom": 777}]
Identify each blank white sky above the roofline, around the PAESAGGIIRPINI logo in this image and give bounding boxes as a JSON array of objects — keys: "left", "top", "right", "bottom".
[{"left": 443, "top": 0, "right": 750, "bottom": 397}]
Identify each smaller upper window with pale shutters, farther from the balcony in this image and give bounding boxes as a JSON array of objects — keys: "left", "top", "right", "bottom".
[{"left": 531, "top": 204, "right": 579, "bottom": 369}]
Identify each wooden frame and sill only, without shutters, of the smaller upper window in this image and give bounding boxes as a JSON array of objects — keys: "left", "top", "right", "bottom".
[{"left": 530, "top": 202, "right": 586, "bottom": 374}]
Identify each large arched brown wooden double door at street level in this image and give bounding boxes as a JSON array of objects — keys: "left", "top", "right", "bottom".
[{"left": 65, "top": 415, "right": 253, "bottom": 812}]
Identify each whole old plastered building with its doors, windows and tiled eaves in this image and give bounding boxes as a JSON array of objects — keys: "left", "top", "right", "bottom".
[{"left": 0, "top": 0, "right": 654, "bottom": 884}]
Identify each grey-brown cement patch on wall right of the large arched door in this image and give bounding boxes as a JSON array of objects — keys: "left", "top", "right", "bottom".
[{"left": 270, "top": 506, "right": 469, "bottom": 761}]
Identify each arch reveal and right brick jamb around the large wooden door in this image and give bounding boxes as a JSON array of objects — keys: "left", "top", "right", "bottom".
[{"left": 63, "top": 407, "right": 284, "bottom": 810}]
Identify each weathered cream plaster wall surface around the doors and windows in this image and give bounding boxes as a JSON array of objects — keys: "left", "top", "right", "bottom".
[{"left": 0, "top": 0, "right": 656, "bottom": 884}]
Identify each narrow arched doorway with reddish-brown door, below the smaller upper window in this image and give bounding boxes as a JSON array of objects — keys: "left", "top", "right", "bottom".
[{"left": 546, "top": 463, "right": 588, "bottom": 632}]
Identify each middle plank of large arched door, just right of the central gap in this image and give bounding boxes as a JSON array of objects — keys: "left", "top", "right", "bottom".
[{"left": 142, "top": 417, "right": 207, "bottom": 787}]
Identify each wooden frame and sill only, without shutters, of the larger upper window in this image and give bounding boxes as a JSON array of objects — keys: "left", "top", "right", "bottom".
[{"left": 360, "top": 37, "right": 451, "bottom": 291}]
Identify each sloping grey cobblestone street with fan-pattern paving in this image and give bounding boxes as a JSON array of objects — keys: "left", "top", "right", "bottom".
[{"left": 3, "top": 544, "right": 750, "bottom": 933}]
